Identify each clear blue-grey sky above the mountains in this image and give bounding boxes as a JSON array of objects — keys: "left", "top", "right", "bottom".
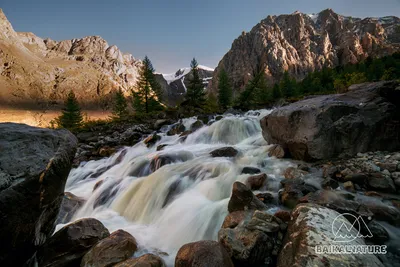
[{"left": 0, "top": 0, "right": 400, "bottom": 73}]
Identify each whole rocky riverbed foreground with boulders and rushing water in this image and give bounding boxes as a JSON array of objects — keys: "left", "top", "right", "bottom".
[{"left": 0, "top": 82, "right": 400, "bottom": 267}]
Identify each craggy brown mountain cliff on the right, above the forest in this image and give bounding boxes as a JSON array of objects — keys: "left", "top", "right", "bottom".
[{"left": 209, "top": 9, "right": 400, "bottom": 96}]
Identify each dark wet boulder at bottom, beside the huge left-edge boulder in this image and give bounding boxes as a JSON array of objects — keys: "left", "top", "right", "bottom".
[{"left": 29, "top": 218, "right": 110, "bottom": 267}]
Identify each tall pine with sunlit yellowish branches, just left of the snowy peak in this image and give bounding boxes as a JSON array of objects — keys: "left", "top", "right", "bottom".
[{"left": 132, "top": 56, "right": 162, "bottom": 113}]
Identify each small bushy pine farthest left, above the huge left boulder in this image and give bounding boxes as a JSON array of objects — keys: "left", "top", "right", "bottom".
[{"left": 55, "top": 90, "right": 83, "bottom": 131}]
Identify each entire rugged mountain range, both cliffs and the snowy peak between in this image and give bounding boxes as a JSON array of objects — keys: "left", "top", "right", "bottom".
[{"left": 0, "top": 9, "right": 400, "bottom": 108}]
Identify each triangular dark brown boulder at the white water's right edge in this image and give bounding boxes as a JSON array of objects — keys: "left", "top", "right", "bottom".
[{"left": 228, "top": 182, "right": 266, "bottom": 212}]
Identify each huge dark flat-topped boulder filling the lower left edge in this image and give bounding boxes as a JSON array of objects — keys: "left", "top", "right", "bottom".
[{"left": 0, "top": 123, "right": 77, "bottom": 266}]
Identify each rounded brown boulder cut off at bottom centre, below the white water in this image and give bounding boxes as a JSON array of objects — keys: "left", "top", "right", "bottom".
[{"left": 175, "top": 240, "right": 233, "bottom": 267}]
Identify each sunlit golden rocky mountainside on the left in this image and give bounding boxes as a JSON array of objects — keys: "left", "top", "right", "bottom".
[{"left": 0, "top": 9, "right": 141, "bottom": 107}]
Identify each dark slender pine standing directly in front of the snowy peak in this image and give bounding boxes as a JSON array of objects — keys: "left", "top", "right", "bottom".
[{"left": 186, "top": 58, "right": 206, "bottom": 109}]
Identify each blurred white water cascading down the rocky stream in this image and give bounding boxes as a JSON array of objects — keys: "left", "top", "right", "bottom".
[{"left": 58, "top": 110, "right": 292, "bottom": 265}]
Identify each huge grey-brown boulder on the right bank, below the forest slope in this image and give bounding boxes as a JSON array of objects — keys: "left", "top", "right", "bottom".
[{"left": 261, "top": 81, "right": 400, "bottom": 161}]
